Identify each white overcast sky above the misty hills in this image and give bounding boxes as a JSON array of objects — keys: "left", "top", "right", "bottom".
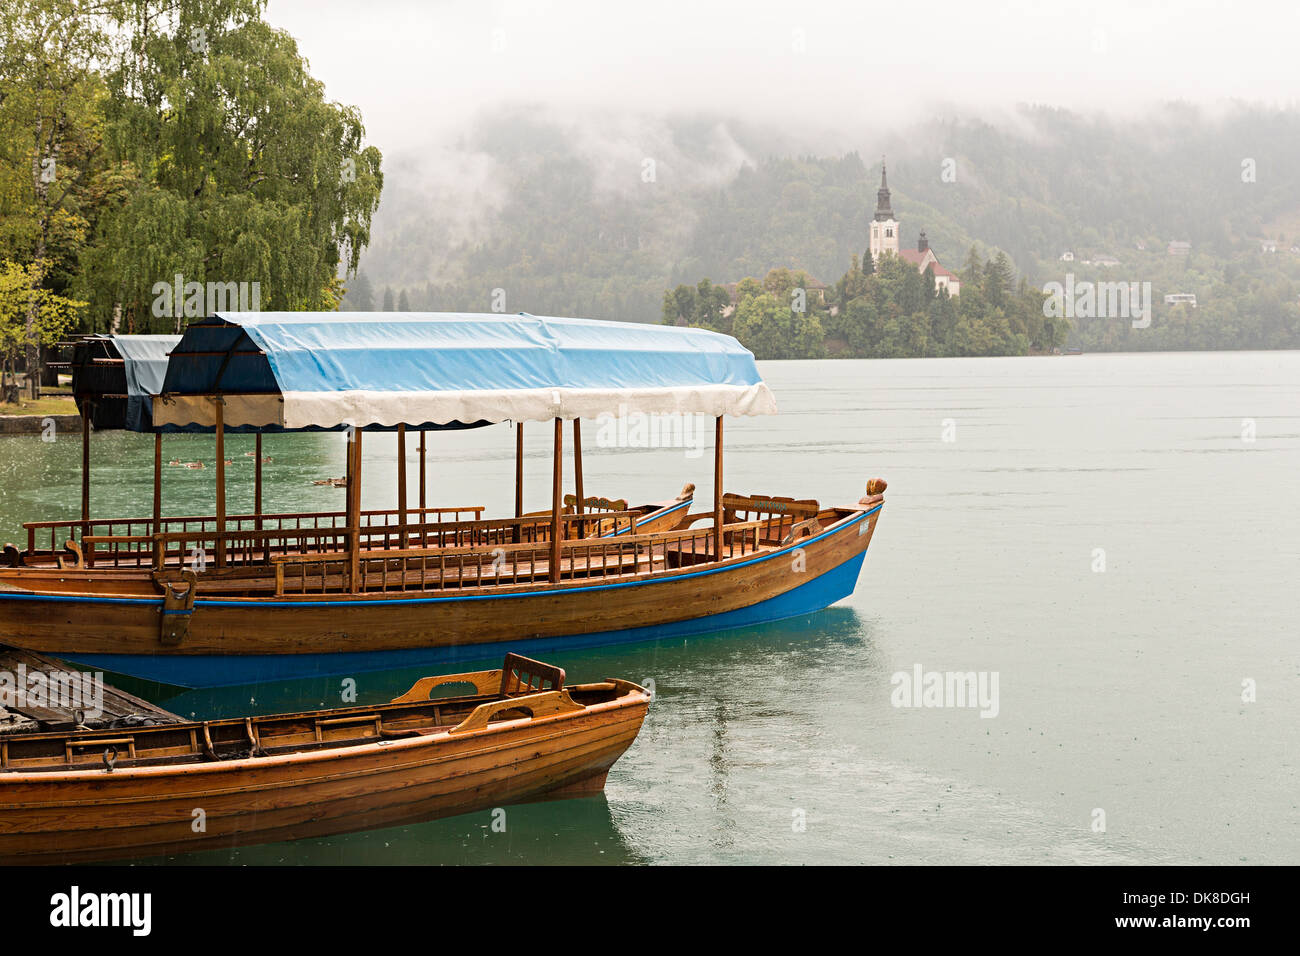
[{"left": 267, "top": 0, "right": 1300, "bottom": 150}]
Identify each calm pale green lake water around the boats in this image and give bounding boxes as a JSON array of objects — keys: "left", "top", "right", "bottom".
[{"left": 0, "top": 352, "right": 1300, "bottom": 864}]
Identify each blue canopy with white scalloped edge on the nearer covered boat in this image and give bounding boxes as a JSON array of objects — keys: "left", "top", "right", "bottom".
[{"left": 153, "top": 312, "right": 776, "bottom": 428}]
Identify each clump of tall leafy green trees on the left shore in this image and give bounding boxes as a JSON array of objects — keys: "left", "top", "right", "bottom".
[{"left": 0, "top": 0, "right": 384, "bottom": 381}]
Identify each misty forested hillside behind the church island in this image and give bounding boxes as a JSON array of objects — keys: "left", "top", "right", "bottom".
[{"left": 345, "top": 104, "right": 1300, "bottom": 347}]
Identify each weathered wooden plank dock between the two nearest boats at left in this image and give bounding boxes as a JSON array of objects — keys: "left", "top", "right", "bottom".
[{"left": 0, "top": 644, "right": 183, "bottom": 736}]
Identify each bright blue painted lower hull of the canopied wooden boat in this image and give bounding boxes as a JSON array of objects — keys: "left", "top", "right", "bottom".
[{"left": 60, "top": 551, "right": 866, "bottom": 688}]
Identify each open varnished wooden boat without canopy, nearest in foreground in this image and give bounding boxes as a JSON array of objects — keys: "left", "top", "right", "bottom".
[{"left": 0, "top": 654, "right": 650, "bottom": 865}]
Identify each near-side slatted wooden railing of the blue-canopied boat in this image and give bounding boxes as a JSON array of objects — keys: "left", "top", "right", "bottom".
[{"left": 270, "top": 522, "right": 763, "bottom": 597}]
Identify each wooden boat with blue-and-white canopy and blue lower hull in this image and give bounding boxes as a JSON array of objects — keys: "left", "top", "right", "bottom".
[{"left": 0, "top": 313, "right": 885, "bottom": 687}]
